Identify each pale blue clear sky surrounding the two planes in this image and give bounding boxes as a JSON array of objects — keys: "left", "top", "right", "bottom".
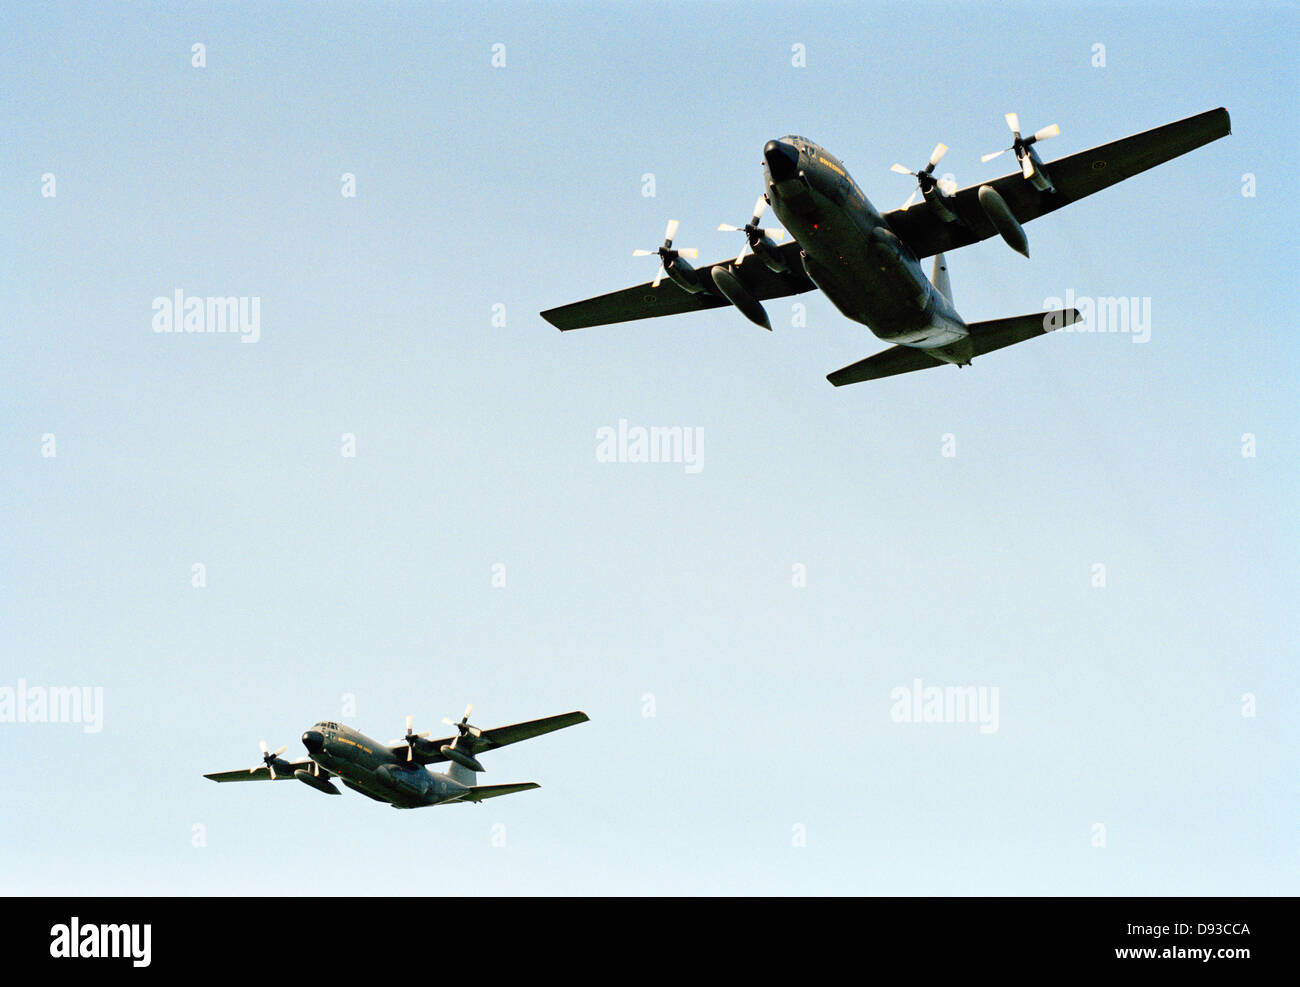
[{"left": 0, "top": 3, "right": 1300, "bottom": 896}]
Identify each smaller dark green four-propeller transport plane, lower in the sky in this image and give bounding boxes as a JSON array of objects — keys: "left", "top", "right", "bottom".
[{"left": 204, "top": 705, "right": 588, "bottom": 809}]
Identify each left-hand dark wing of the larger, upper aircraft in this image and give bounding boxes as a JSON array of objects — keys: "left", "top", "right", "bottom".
[{"left": 542, "top": 241, "right": 816, "bottom": 330}]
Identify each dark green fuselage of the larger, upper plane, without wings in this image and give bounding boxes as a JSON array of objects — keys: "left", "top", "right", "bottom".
[{"left": 763, "top": 137, "right": 970, "bottom": 364}]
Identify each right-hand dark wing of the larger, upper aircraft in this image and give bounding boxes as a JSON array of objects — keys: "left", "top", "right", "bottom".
[{"left": 885, "top": 107, "right": 1231, "bottom": 257}]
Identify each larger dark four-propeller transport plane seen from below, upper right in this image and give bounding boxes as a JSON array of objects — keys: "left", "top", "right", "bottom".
[{"left": 542, "top": 107, "right": 1230, "bottom": 386}]
